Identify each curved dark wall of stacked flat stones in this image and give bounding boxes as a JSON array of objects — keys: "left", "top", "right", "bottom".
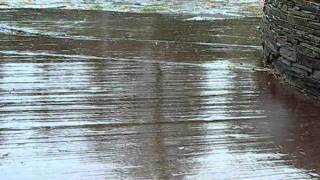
[{"left": 262, "top": 0, "right": 320, "bottom": 96}]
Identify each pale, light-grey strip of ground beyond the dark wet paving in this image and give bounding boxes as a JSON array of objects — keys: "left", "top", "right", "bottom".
[{"left": 0, "top": 0, "right": 262, "bottom": 19}]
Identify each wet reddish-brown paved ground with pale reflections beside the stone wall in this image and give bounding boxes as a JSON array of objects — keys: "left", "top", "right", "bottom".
[{"left": 0, "top": 1, "right": 320, "bottom": 179}]
